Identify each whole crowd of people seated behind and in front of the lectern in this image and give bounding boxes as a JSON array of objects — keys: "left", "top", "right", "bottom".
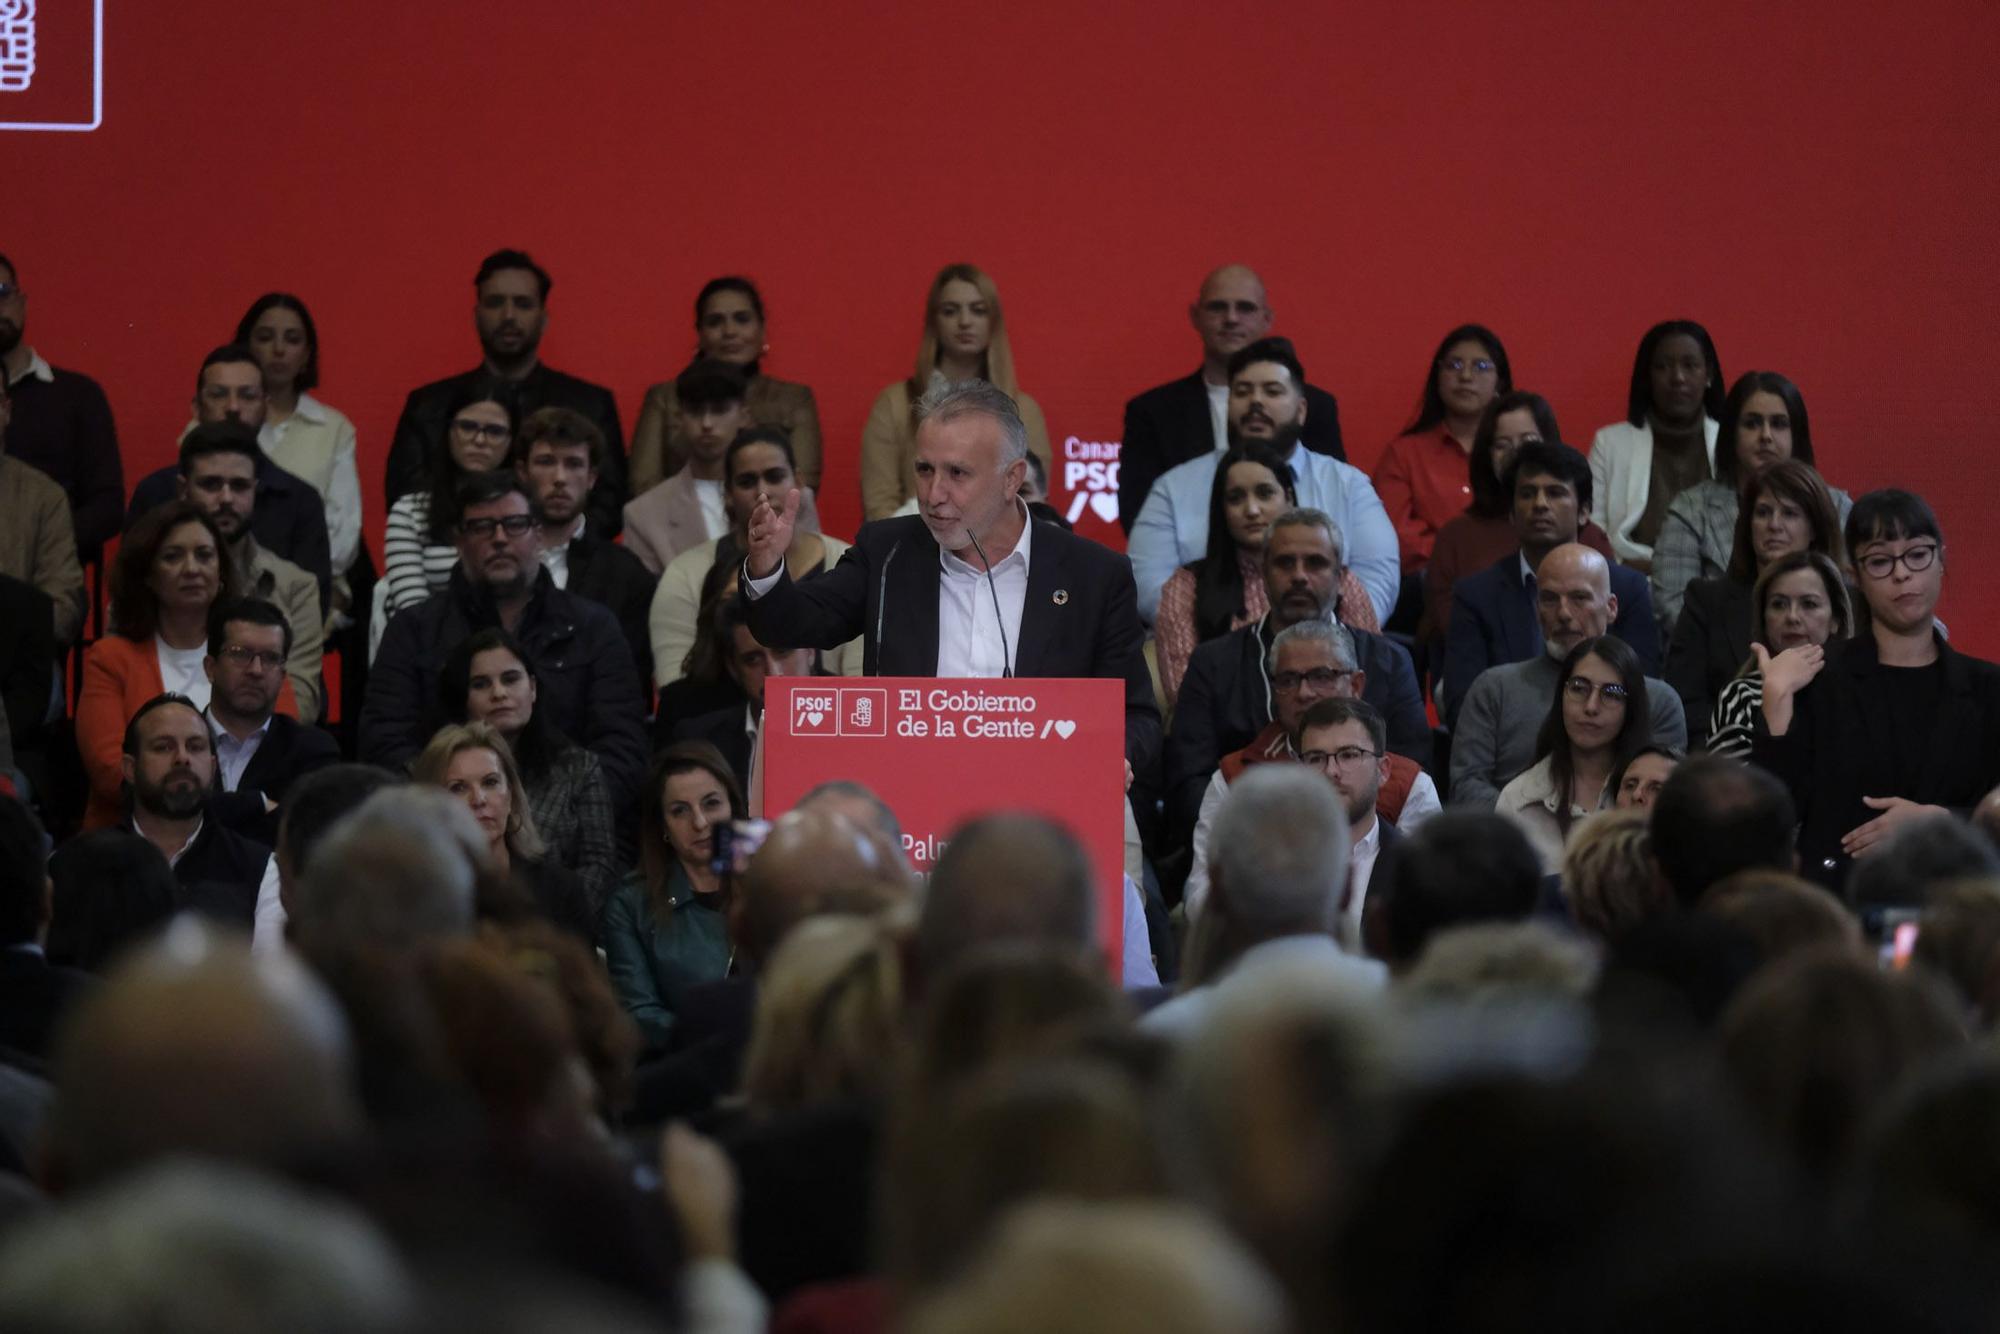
[{"left": 0, "top": 250, "right": 2000, "bottom": 1332}]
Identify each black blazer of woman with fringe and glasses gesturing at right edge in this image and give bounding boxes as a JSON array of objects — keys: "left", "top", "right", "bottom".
[{"left": 1752, "top": 632, "right": 2000, "bottom": 884}]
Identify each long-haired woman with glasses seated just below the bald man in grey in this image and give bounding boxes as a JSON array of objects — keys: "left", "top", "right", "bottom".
[{"left": 1494, "top": 634, "right": 1652, "bottom": 876}]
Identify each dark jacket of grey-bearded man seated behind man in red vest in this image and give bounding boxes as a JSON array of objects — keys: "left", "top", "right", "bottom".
[{"left": 1166, "top": 620, "right": 1434, "bottom": 830}]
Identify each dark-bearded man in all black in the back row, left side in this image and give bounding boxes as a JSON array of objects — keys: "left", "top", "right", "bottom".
[{"left": 386, "top": 250, "right": 626, "bottom": 542}]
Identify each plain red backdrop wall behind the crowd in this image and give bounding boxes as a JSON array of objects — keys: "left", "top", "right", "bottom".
[{"left": 0, "top": 0, "right": 2000, "bottom": 656}]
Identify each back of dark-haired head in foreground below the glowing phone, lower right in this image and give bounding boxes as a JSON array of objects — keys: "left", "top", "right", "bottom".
[{"left": 1720, "top": 950, "right": 1966, "bottom": 1186}]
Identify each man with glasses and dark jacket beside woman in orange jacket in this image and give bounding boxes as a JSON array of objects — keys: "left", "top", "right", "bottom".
[{"left": 202, "top": 598, "right": 340, "bottom": 846}]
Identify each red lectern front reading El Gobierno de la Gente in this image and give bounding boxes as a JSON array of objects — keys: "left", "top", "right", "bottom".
[{"left": 762, "top": 676, "right": 1124, "bottom": 958}]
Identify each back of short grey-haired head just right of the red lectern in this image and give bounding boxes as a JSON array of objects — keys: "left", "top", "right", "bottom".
[{"left": 1208, "top": 764, "right": 1348, "bottom": 932}]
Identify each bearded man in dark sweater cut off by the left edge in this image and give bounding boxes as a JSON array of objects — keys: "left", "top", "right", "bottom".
[{"left": 0, "top": 254, "right": 124, "bottom": 560}]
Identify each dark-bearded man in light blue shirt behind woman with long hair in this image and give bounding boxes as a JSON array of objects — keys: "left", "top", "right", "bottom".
[{"left": 1126, "top": 338, "right": 1402, "bottom": 624}]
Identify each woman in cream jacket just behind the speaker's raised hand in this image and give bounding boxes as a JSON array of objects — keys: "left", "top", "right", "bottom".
[{"left": 648, "top": 426, "right": 860, "bottom": 690}]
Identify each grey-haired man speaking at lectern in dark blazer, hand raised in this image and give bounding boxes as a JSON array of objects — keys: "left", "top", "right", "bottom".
[{"left": 742, "top": 380, "right": 1160, "bottom": 790}]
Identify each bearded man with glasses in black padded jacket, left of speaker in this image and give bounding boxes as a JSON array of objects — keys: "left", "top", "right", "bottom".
[{"left": 360, "top": 472, "right": 646, "bottom": 810}]
